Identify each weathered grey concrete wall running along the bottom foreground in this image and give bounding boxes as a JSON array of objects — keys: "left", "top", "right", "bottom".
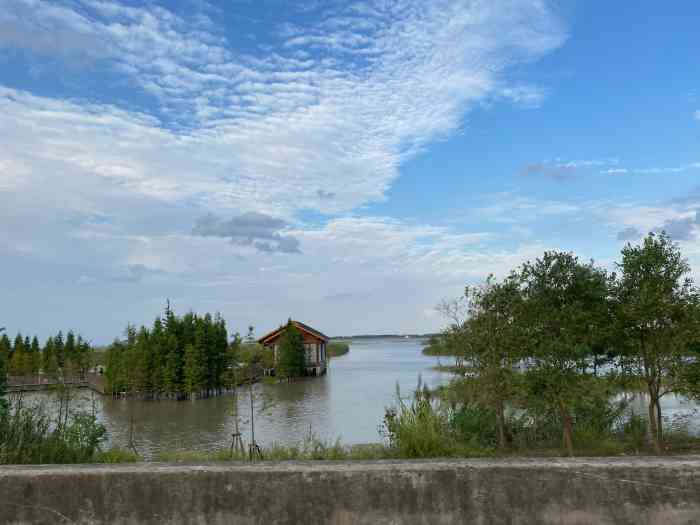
[{"left": 0, "top": 457, "right": 700, "bottom": 525}]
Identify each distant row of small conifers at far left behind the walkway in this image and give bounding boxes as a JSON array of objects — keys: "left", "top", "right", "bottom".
[{"left": 0, "top": 332, "right": 92, "bottom": 379}]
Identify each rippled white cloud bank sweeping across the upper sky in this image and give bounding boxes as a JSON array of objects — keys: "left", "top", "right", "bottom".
[{"left": 0, "top": 0, "right": 565, "bottom": 213}]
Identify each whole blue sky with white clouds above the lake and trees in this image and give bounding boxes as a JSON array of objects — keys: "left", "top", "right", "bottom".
[{"left": 0, "top": 0, "right": 700, "bottom": 344}]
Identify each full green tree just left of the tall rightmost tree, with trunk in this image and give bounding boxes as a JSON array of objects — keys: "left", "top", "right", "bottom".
[{"left": 520, "top": 252, "right": 610, "bottom": 455}]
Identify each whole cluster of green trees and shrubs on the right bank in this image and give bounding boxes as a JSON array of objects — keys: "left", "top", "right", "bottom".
[{"left": 430, "top": 234, "right": 700, "bottom": 454}]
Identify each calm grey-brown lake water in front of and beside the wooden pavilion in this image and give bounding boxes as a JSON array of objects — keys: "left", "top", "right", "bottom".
[{"left": 53, "top": 339, "right": 449, "bottom": 457}]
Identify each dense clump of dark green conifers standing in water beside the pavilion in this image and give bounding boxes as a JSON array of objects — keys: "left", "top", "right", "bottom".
[{"left": 105, "top": 306, "right": 232, "bottom": 399}]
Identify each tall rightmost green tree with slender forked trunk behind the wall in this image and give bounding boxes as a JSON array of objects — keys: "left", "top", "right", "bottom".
[{"left": 615, "top": 232, "right": 698, "bottom": 453}]
